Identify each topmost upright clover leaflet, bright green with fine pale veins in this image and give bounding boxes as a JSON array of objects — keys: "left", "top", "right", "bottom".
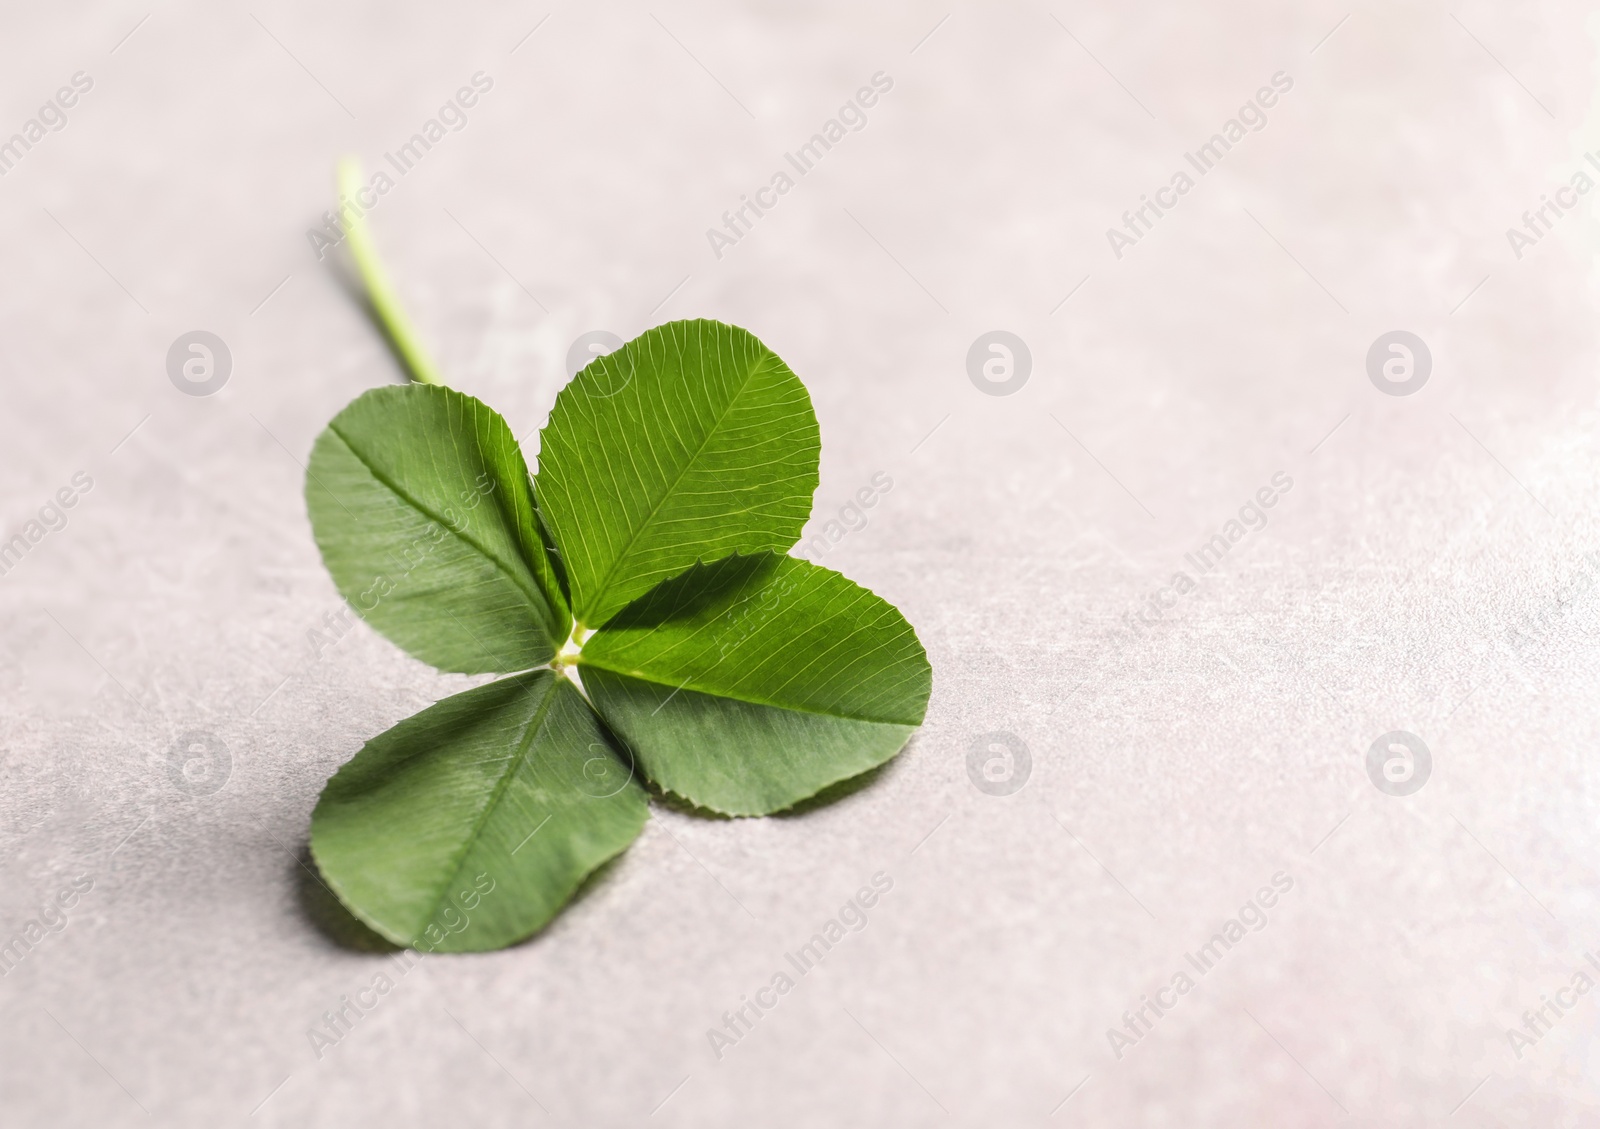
[{"left": 538, "top": 321, "right": 822, "bottom": 628}]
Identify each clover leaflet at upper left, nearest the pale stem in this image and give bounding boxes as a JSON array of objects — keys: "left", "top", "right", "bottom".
[{"left": 306, "top": 384, "right": 571, "bottom": 675}]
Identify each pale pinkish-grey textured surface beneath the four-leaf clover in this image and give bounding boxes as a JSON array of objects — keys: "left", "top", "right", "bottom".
[{"left": 0, "top": 0, "right": 1600, "bottom": 1126}]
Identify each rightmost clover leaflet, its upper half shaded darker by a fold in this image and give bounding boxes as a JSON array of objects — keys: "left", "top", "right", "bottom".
[{"left": 578, "top": 553, "right": 933, "bottom": 816}]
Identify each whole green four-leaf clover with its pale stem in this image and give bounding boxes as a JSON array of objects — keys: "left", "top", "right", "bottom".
[{"left": 306, "top": 166, "right": 931, "bottom": 951}]
